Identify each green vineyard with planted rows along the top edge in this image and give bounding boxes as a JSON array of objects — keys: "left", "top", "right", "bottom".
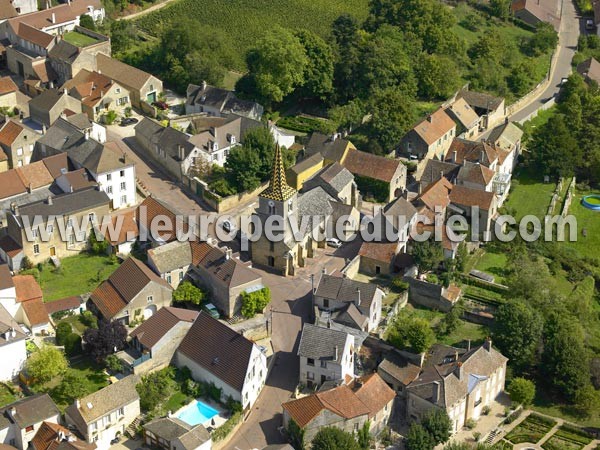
[{"left": 135, "top": 0, "right": 368, "bottom": 71}]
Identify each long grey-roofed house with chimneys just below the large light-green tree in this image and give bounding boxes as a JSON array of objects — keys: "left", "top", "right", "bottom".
[{"left": 185, "top": 81, "right": 264, "bottom": 120}]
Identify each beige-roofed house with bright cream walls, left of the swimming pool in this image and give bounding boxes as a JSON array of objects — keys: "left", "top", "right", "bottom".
[{"left": 65, "top": 375, "right": 140, "bottom": 450}]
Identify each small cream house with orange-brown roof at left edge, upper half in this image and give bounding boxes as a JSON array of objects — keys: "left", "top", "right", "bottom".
[{"left": 0, "top": 119, "right": 42, "bottom": 169}]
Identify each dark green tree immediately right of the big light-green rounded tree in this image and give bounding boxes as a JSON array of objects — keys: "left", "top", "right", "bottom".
[{"left": 295, "top": 30, "right": 334, "bottom": 100}]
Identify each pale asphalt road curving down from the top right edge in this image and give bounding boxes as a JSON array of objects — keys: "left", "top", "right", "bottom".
[{"left": 509, "top": 0, "right": 582, "bottom": 122}]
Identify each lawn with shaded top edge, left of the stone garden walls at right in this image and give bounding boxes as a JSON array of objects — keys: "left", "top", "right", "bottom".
[{"left": 504, "top": 169, "right": 556, "bottom": 222}]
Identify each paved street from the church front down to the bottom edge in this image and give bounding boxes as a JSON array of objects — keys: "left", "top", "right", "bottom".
[{"left": 226, "top": 243, "right": 357, "bottom": 450}]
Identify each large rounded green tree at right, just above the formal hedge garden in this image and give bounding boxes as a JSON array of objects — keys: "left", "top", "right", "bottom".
[{"left": 542, "top": 311, "right": 590, "bottom": 401}]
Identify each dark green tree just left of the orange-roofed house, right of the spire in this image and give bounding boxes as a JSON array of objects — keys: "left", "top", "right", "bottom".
[{"left": 367, "top": 88, "right": 414, "bottom": 152}]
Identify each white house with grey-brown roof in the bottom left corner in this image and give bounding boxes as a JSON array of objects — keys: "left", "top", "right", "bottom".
[{"left": 0, "top": 394, "right": 60, "bottom": 450}]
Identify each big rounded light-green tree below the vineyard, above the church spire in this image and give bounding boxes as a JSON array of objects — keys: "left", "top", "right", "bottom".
[{"left": 246, "top": 27, "right": 309, "bottom": 105}]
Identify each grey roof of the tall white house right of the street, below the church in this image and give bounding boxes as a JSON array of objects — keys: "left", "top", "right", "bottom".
[{"left": 298, "top": 323, "right": 349, "bottom": 363}]
